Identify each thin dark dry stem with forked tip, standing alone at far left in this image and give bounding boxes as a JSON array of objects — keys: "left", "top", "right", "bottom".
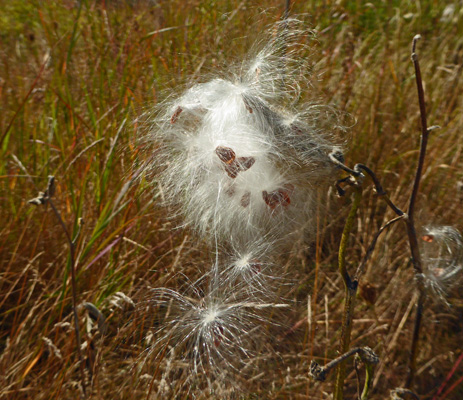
[{"left": 29, "top": 176, "right": 87, "bottom": 398}]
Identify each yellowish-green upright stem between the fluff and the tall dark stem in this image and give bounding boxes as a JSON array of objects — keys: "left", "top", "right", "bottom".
[{"left": 334, "top": 186, "right": 362, "bottom": 400}]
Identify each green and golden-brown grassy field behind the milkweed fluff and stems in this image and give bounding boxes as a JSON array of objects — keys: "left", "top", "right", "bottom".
[{"left": 0, "top": 0, "right": 463, "bottom": 400}]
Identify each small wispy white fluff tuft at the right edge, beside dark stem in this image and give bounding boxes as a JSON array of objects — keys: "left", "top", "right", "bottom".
[{"left": 422, "top": 226, "right": 463, "bottom": 301}]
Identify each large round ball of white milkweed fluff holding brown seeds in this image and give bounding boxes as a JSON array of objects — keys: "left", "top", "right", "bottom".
[{"left": 149, "top": 21, "right": 344, "bottom": 240}]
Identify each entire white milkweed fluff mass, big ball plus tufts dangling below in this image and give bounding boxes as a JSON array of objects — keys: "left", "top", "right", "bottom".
[{"left": 140, "top": 21, "right": 346, "bottom": 394}]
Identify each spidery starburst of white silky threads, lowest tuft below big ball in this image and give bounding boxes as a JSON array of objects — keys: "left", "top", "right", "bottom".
[{"left": 140, "top": 276, "right": 285, "bottom": 385}]
